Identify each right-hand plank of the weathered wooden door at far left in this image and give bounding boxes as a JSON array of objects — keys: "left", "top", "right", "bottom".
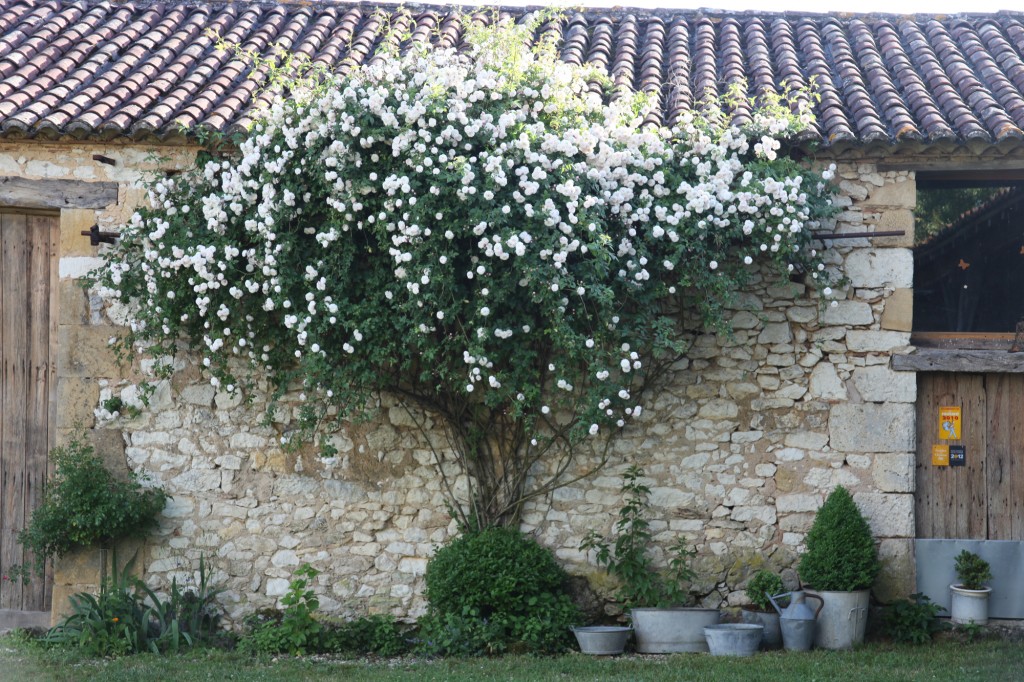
[{"left": 23, "top": 216, "right": 53, "bottom": 611}]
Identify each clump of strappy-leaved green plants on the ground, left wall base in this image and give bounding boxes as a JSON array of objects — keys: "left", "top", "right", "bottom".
[{"left": 43, "top": 554, "right": 220, "bottom": 656}]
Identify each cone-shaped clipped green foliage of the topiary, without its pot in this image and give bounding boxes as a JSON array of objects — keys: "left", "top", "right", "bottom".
[{"left": 799, "top": 485, "right": 882, "bottom": 592}]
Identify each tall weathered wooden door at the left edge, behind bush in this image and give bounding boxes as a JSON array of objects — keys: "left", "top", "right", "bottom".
[{"left": 0, "top": 209, "right": 60, "bottom": 611}]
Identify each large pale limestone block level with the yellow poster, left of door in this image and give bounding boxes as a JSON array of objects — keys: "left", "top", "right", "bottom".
[{"left": 828, "top": 402, "right": 916, "bottom": 453}]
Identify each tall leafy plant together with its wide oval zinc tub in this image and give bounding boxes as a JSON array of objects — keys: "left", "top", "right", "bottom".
[{"left": 580, "top": 465, "right": 719, "bottom": 653}]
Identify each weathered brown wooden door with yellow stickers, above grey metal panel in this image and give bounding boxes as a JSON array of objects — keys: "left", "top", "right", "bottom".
[{"left": 915, "top": 373, "right": 1024, "bottom": 541}]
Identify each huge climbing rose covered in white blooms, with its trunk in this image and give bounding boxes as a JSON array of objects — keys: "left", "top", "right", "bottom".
[{"left": 97, "top": 14, "right": 833, "bottom": 525}]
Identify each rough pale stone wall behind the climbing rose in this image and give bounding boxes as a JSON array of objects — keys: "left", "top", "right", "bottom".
[{"left": 29, "top": 140, "right": 937, "bottom": 621}]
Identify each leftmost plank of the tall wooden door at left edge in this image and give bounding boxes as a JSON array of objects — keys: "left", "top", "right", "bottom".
[{"left": 0, "top": 214, "right": 29, "bottom": 609}]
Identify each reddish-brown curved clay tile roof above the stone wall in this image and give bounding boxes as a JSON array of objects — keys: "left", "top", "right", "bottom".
[{"left": 0, "top": 0, "right": 1024, "bottom": 144}]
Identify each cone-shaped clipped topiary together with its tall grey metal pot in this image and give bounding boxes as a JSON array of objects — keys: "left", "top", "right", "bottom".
[{"left": 799, "top": 485, "right": 882, "bottom": 649}]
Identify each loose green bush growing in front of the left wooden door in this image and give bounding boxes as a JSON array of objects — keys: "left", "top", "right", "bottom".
[{"left": 11, "top": 438, "right": 168, "bottom": 581}]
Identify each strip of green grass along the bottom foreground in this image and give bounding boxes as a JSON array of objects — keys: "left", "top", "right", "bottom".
[{"left": 0, "top": 636, "right": 1024, "bottom": 682}]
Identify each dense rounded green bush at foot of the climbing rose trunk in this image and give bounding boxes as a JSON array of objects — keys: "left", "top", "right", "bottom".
[{"left": 419, "top": 528, "right": 579, "bottom": 655}]
